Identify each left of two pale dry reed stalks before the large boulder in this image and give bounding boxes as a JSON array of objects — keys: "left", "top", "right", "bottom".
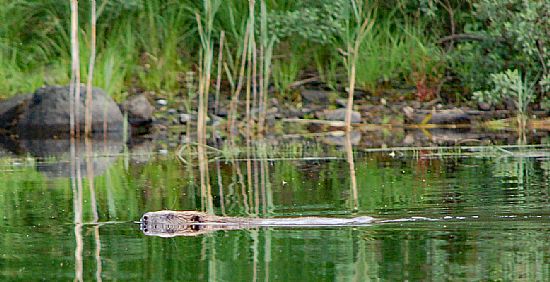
[{"left": 69, "top": 0, "right": 80, "bottom": 137}]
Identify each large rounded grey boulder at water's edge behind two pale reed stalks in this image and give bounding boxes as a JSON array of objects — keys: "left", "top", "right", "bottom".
[{"left": 13, "top": 86, "right": 123, "bottom": 136}]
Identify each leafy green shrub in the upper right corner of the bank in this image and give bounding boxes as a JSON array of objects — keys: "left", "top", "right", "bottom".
[{"left": 451, "top": 0, "right": 550, "bottom": 97}]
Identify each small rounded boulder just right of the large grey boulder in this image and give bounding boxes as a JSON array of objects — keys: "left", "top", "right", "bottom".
[{"left": 121, "top": 94, "right": 155, "bottom": 127}]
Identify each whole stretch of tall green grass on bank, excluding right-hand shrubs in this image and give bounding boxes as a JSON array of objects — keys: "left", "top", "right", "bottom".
[{"left": 0, "top": 0, "right": 446, "bottom": 103}]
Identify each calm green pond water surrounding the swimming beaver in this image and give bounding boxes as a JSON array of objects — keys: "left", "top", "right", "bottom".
[{"left": 0, "top": 140, "right": 550, "bottom": 281}]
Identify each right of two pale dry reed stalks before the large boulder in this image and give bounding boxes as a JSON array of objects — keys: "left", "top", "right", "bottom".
[{"left": 84, "top": 0, "right": 97, "bottom": 136}]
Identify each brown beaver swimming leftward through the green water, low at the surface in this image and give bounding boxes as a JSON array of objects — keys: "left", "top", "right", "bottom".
[{"left": 140, "top": 210, "right": 377, "bottom": 237}]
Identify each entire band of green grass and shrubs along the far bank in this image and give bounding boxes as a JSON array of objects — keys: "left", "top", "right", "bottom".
[{"left": 0, "top": 0, "right": 550, "bottom": 107}]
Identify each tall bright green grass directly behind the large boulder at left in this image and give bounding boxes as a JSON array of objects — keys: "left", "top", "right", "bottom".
[{"left": 0, "top": 0, "right": 196, "bottom": 98}]
